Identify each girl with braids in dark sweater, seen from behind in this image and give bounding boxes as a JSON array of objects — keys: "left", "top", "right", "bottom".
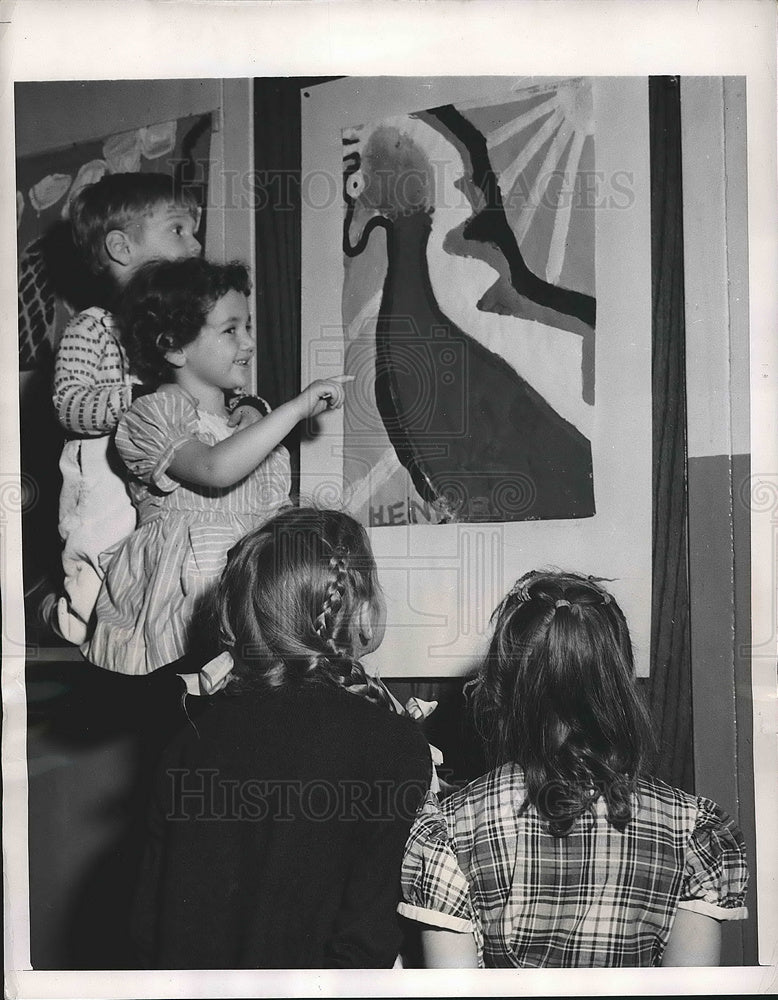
[{"left": 136, "top": 508, "right": 431, "bottom": 969}]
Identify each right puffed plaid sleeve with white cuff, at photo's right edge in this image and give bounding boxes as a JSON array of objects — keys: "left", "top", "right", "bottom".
[{"left": 678, "top": 797, "right": 748, "bottom": 920}]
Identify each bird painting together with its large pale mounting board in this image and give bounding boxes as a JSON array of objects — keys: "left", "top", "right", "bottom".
[{"left": 300, "top": 77, "right": 652, "bottom": 677}]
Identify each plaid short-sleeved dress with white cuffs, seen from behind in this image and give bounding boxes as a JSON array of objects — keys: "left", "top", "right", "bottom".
[{"left": 398, "top": 764, "right": 748, "bottom": 968}]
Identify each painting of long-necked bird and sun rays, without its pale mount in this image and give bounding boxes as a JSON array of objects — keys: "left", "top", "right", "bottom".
[{"left": 341, "top": 79, "right": 597, "bottom": 527}]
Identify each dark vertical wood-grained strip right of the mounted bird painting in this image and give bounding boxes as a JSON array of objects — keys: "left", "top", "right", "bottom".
[{"left": 645, "top": 77, "right": 694, "bottom": 792}]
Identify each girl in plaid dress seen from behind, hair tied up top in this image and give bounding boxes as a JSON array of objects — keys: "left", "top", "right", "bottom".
[{"left": 399, "top": 572, "right": 748, "bottom": 968}]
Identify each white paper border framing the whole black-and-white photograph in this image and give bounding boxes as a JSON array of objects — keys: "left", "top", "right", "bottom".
[{"left": 0, "top": 0, "right": 778, "bottom": 998}]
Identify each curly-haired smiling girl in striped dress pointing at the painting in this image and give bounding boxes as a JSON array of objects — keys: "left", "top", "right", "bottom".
[{"left": 85, "top": 258, "right": 344, "bottom": 674}]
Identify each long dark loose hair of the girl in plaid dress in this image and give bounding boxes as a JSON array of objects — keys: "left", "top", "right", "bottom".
[{"left": 470, "top": 571, "right": 653, "bottom": 836}]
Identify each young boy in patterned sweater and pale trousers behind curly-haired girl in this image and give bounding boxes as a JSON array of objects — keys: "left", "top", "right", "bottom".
[{"left": 50, "top": 173, "right": 259, "bottom": 645}]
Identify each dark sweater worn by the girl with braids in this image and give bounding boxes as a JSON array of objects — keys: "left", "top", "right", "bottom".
[{"left": 130, "top": 684, "right": 430, "bottom": 969}]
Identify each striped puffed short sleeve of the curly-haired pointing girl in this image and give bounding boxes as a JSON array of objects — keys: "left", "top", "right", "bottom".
[{"left": 116, "top": 392, "right": 198, "bottom": 493}]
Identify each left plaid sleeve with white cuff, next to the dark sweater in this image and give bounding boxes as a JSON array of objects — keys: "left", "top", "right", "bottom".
[{"left": 397, "top": 792, "right": 478, "bottom": 939}]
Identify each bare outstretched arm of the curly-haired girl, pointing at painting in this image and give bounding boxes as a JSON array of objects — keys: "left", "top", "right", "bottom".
[{"left": 168, "top": 375, "right": 353, "bottom": 489}]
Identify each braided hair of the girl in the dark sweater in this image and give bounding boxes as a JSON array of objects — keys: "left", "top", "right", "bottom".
[{"left": 216, "top": 507, "right": 392, "bottom": 708}]
